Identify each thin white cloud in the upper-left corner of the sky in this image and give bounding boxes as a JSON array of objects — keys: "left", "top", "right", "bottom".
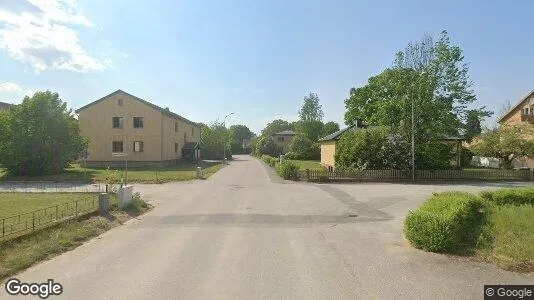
[{"left": 0, "top": 0, "right": 111, "bottom": 72}]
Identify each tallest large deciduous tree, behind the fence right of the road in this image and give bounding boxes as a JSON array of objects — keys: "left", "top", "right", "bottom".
[{"left": 345, "top": 31, "right": 491, "bottom": 168}]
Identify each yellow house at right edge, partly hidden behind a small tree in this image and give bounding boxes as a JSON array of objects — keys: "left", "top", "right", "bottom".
[{"left": 498, "top": 90, "right": 534, "bottom": 168}]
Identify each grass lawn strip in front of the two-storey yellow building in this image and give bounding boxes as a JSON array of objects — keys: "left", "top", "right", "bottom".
[{"left": 0, "top": 162, "right": 223, "bottom": 183}]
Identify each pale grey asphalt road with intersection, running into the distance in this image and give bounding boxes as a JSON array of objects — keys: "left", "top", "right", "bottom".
[{"left": 0, "top": 156, "right": 534, "bottom": 300}]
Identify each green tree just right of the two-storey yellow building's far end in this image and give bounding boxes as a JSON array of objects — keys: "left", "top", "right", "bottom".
[{"left": 200, "top": 122, "right": 231, "bottom": 159}]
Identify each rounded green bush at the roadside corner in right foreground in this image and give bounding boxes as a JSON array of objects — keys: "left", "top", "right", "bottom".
[{"left": 404, "top": 192, "right": 485, "bottom": 253}]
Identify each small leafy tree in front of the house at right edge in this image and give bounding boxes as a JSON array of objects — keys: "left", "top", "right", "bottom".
[{"left": 471, "top": 124, "right": 534, "bottom": 169}]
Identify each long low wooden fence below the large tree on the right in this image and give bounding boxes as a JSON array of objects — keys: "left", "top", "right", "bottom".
[{"left": 299, "top": 169, "right": 534, "bottom": 181}]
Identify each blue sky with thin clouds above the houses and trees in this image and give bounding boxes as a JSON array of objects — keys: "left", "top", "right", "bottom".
[{"left": 0, "top": 0, "right": 534, "bottom": 133}]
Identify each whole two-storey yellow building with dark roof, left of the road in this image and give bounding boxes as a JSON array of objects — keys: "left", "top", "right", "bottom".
[{"left": 76, "top": 90, "right": 200, "bottom": 167}]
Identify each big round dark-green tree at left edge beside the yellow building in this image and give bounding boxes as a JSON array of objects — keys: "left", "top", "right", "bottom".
[{"left": 0, "top": 91, "right": 88, "bottom": 175}]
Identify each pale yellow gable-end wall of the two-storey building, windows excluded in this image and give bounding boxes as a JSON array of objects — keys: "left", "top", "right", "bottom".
[{"left": 78, "top": 93, "right": 163, "bottom": 162}]
